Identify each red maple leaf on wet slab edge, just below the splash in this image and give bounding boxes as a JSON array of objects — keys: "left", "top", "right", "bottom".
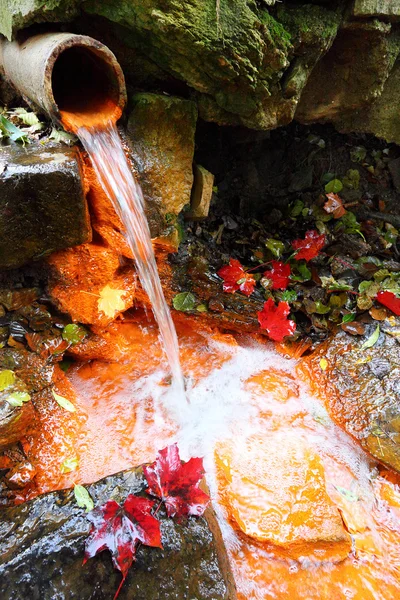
[{"left": 143, "top": 444, "right": 210, "bottom": 517}]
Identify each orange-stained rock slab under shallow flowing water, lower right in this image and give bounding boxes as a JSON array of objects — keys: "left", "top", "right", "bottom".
[{"left": 217, "top": 430, "right": 351, "bottom": 562}]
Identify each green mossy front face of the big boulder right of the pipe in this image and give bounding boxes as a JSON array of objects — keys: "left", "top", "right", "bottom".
[{"left": 83, "top": 0, "right": 291, "bottom": 127}]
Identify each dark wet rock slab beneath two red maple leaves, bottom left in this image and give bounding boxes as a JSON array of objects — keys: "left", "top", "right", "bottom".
[{"left": 0, "top": 469, "right": 236, "bottom": 600}]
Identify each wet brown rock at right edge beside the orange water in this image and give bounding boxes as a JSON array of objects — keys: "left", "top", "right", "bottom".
[{"left": 300, "top": 316, "right": 400, "bottom": 471}]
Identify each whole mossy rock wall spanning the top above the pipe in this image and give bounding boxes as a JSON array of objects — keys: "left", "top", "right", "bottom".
[{"left": 0, "top": 0, "right": 400, "bottom": 141}]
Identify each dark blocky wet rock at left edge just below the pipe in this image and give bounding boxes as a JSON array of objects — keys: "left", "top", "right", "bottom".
[{"left": 0, "top": 144, "right": 92, "bottom": 268}]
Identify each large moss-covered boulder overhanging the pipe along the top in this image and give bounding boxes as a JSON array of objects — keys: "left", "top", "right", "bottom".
[{"left": 0, "top": 0, "right": 342, "bottom": 129}]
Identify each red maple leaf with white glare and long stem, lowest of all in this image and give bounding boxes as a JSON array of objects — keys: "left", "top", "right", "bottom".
[{"left": 83, "top": 494, "right": 162, "bottom": 600}]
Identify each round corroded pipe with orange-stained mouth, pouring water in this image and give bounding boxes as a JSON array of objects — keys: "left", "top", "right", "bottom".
[{"left": 0, "top": 33, "right": 126, "bottom": 131}]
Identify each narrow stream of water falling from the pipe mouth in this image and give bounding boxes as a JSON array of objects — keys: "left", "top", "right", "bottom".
[{"left": 77, "top": 123, "right": 186, "bottom": 404}]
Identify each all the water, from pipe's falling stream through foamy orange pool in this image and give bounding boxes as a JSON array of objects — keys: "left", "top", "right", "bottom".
[{"left": 43, "top": 119, "right": 400, "bottom": 600}]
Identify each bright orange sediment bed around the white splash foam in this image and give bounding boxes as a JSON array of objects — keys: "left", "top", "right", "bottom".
[{"left": 17, "top": 314, "right": 400, "bottom": 600}]
